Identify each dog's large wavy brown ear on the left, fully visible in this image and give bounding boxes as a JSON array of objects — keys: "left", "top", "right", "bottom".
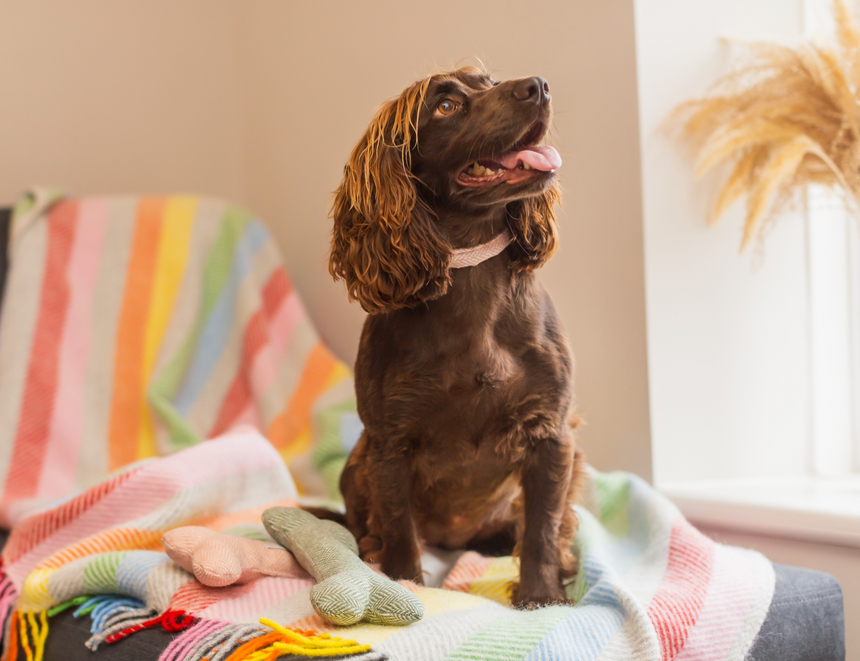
[{"left": 329, "top": 80, "right": 451, "bottom": 314}]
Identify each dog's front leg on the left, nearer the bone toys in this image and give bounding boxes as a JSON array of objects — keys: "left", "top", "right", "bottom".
[{"left": 370, "top": 449, "right": 423, "bottom": 583}]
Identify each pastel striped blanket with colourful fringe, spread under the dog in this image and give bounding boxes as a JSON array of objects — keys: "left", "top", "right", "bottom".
[{"left": 0, "top": 430, "right": 774, "bottom": 661}]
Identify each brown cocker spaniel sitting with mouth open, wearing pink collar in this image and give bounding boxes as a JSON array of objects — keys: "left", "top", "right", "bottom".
[{"left": 330, "top": 68, "right": 584, "bottom": 605}]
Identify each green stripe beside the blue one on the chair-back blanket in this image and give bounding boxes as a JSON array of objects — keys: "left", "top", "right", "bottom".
[{"left": 148, "top": 207, "right": 251, "bottom": 450}]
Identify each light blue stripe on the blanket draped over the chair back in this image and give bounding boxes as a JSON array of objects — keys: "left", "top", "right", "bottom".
[{"left": 174, "top": 222, "right": 269, "bottom": 416}]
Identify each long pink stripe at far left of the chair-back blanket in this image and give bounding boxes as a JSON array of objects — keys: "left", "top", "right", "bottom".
[{"left": 38, "top": 199, "right": 108, "bottom": 497}]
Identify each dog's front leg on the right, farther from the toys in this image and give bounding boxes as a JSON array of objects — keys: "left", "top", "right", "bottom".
[{"left": 513, "top": 439, "right": 573, "bottom": 606}]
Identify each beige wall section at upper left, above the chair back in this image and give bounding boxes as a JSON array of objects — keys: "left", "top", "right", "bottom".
[{"left": 0, "top": 0, "right": 245, "bottom": 203}]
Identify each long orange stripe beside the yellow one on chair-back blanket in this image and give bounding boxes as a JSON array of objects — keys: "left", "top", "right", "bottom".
[{"left": 108, "top": 198, "right": 165, "bottom": 470}]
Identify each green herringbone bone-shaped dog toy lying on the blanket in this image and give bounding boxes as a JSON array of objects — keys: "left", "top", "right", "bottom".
[{"left": 263, "top": 507, "right": 424, "bottom": 626}]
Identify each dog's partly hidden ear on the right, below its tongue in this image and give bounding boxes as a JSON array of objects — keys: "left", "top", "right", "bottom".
[{"left": 508, "top": 183, "right": 561, "bottom": 271}]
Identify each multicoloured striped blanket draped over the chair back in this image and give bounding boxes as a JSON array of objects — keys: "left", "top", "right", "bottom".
[{"left": 0, "top": 189, "right": 352, "bottom": 528}]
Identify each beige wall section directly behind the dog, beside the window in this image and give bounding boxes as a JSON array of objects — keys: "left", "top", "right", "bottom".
[{"left": 242, "top": 0, "right": 650, "bottom": 477}]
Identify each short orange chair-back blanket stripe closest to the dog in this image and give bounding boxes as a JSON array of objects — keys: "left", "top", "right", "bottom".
[{"left": 268, "top": 344, "right": 337, "bottom": 448}]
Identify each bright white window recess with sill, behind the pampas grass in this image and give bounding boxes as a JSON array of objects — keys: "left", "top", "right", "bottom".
[{"left": 636, "top": 0, "right": 860, "bottom": 546}]
